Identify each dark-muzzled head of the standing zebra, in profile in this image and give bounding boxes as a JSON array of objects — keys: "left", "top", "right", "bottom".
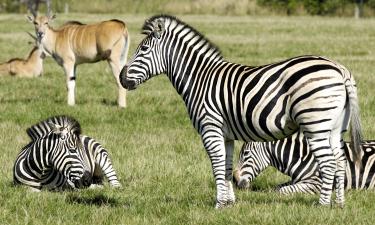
[{"left": 120, "top": 17, "right": 166, "bottom": 90}]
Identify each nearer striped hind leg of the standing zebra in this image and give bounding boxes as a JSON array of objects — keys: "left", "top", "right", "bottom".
[{"left": 304, "top": 132, "right": 336, "bottom": 206}]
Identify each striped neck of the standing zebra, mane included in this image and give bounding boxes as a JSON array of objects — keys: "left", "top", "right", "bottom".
[{"left": 155, "top": 16, "right": 222, "bottom": 128}]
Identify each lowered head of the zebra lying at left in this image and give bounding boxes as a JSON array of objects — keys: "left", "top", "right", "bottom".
[{"left": 47, "top": 118, "right": 92, "bottom": 188}]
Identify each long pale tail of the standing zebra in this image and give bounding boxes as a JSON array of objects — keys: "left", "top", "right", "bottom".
[{"left": 343, "top": 68, "right": 362, "bottom": 166}]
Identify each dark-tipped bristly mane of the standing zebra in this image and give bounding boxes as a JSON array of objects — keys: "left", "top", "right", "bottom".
[{"left": 141, "top": 14, "right": 222, "bottom": 58}]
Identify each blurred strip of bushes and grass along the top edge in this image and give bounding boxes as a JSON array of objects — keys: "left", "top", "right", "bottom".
[{"left": 0, "top": 0, "right": 375, "bottom": 17}]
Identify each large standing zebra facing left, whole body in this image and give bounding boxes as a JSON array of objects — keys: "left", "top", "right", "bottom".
[{"left": 120, "top": 15, "right": 361, "bottom": 208}]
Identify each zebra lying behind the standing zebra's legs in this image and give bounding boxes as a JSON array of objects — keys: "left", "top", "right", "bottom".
[{"left": 234, "top": 133, "right": 375, "bottom": 194}]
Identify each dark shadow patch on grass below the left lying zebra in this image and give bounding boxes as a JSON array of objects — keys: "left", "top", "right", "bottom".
[{"left": 66, "top": 194, "right": 120, "bottom": 207}]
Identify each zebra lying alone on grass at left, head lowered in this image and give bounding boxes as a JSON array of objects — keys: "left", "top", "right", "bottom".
[{"left": 13, "top": 116, "right": 121, "bottom": 191}]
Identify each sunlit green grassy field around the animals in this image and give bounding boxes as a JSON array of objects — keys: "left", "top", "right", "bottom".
[{"left": 0, "top": 14, "right": 375, "bottom": 224}]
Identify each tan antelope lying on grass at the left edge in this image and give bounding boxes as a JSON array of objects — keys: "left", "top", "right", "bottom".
[{"left": 0, "top": 47, "right": 45, "bottom": 77}]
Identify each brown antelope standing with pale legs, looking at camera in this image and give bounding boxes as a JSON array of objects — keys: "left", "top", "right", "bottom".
[{"left": 28, "top": 13, "right": 130, "bottom": 107}]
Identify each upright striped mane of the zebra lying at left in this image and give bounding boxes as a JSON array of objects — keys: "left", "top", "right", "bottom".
[{"left": 26, "top": 115, "right": 82, "bottom": 141}]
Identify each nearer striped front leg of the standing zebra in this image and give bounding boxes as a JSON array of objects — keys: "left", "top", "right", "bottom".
[{"left": 202, "top": 127, "right": 234, "bottom": 208}]
